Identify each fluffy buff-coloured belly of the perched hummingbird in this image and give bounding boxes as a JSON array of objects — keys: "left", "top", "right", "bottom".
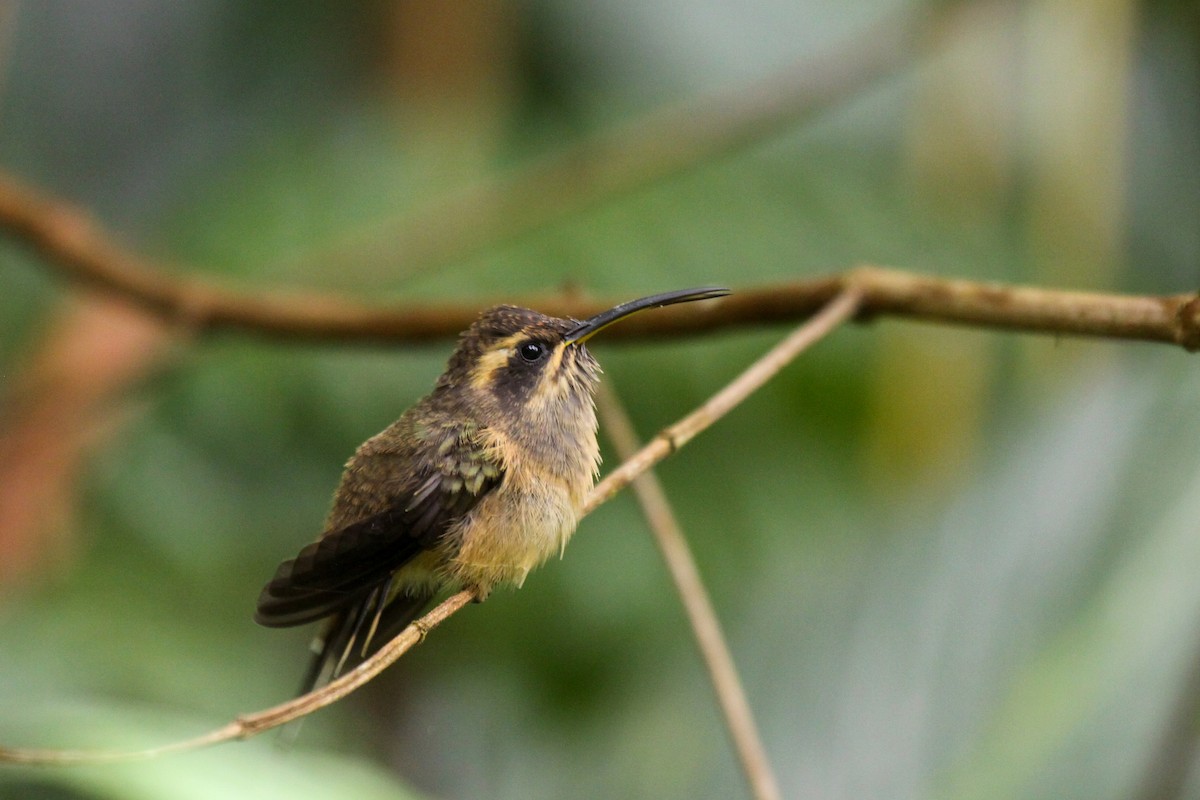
[{"left": 448, "top": 474, "right": 582, "bottom": 595}]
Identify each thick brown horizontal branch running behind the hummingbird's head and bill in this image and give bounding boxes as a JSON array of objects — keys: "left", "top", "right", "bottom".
[{"left": 0, "top": 176, "right": 1200, "bottom": 350}]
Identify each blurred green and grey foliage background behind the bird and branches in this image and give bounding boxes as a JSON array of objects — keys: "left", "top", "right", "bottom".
[{"left": 0, "top": 0, "right": 1200, "bottom": 800}]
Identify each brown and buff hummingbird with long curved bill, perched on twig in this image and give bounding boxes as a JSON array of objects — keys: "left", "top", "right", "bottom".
[{"left": 254, "top": 287, "right": 730, "bottom": 693}]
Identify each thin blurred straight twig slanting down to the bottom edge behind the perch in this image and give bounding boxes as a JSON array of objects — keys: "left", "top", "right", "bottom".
[{"left": 596, "top": 381, "right": 780, "bottom": 800}]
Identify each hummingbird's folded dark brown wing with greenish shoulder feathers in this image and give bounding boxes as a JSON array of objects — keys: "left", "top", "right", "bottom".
[{"left": 254, "top": 427, "right": 504, "bottom": 627}]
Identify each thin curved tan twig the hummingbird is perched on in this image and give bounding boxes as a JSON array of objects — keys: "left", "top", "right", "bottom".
[{"left": 0, "top": 291, "right": 859, "bottom": 765}]
